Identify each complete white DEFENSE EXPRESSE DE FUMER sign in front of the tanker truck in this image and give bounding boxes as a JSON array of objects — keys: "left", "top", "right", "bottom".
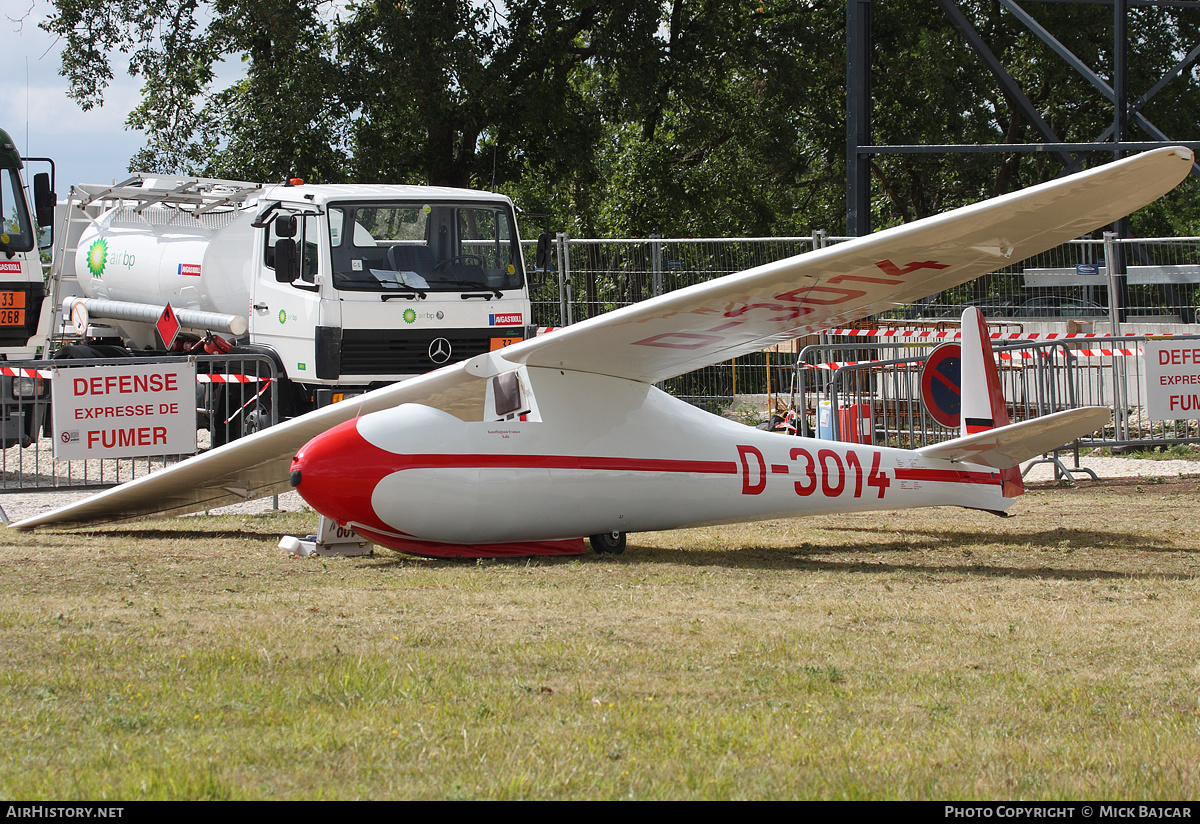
[{"left": 50, "top": 362, "right": 196, "bottom": 461}]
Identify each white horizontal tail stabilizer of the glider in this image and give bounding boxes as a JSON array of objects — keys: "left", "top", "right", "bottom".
[{"left": 917, "top": 407, "right": 1112, "bottom": 469}]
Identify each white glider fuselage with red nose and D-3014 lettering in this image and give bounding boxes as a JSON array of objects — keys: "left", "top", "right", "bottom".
[{"left": 293, "top": 368, "right": 1012, "bottom": 557}]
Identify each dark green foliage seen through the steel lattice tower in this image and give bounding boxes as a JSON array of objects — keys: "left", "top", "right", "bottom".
[{"left": 871, "top": 0, "right": 1200, "bottom": 231}]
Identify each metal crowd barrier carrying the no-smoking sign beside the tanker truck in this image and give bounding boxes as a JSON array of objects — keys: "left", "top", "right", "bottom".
[{"left": 0, "top": 355, "right": 274, "bottom": 492}]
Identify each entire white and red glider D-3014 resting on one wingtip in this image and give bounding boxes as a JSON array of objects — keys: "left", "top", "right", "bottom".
[{"left": 13, "top": 148, "right": 1193, "bottom": 557}]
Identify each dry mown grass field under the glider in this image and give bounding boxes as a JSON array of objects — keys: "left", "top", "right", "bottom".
[{"left": 0, "top": 479, "right": 1200, "bottom": 800}]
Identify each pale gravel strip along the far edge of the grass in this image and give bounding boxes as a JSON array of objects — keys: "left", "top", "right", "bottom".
[{"left": 0, "top": 455, "right": 1200, "bottom": 522}]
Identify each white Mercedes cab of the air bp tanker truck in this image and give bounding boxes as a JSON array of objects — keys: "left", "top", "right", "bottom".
[{"left": 250, "top": 186, "right": 530, "bottom": 387}]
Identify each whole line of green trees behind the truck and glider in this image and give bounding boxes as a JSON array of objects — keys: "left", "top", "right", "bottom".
[{"left": 44, "top": 0, "right": 1200, "bottom": 235}]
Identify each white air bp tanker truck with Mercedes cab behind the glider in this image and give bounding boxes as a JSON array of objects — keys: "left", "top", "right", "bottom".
[{"left": 48, "top": 175, "right": 546, "bottom": 438}]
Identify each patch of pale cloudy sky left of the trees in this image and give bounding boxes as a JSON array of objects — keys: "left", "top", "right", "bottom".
[{"left": 0, "top": 0, "right": 152, "bottom": 189}]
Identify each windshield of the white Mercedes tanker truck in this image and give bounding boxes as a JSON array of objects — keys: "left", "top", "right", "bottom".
[{"left": 329, "top": 203, "right": 522, "bottom": 294}]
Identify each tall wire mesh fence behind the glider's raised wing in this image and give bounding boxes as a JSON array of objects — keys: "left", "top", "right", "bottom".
[{"left": 527, "top": 231, "right": 1200, "bottom": 411}]
